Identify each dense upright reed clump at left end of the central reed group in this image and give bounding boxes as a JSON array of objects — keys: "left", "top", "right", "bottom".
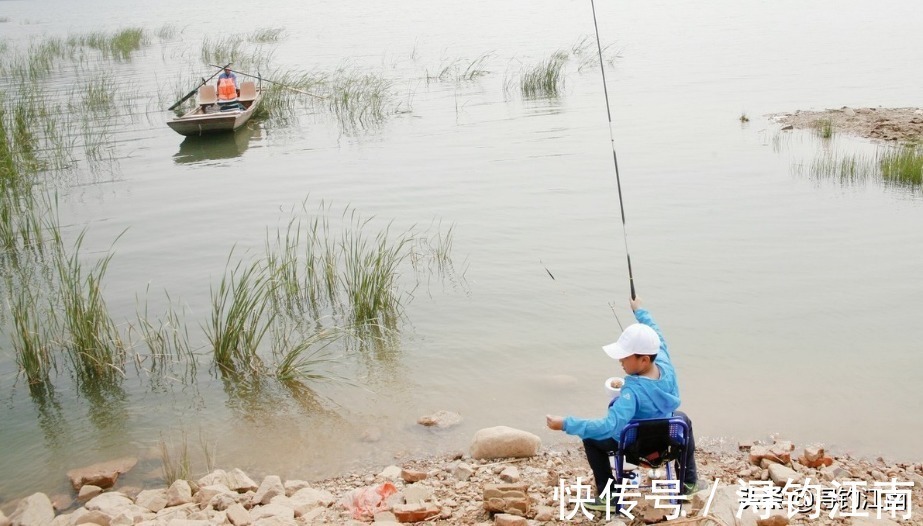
[{"left": 206, "top": 258, "right": 275, "bottom": 375}]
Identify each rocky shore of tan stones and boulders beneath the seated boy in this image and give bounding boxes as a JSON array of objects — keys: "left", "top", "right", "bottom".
[{"left": 0, "top": 426, "right": 923, "bottom": 526}]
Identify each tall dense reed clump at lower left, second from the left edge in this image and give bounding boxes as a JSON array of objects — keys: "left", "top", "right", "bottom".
[{"left": 55, "top": 230, "right": 126, "bottom": 383}]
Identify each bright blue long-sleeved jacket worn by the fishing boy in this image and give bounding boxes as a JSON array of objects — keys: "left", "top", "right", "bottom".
[{"left": 564, "top": 309, "right": 679, "bottom": 441}]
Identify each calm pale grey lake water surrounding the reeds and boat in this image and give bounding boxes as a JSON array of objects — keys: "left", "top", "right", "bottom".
[{"left": 0, "top": 0, "right": 923, "bottom": 502}]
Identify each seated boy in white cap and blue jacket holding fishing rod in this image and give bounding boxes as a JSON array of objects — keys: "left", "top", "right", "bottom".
[{"left": 546, "top": 297, "right": 698, "bottom": 510}]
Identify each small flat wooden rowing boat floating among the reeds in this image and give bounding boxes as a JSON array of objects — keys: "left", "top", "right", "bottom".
[{"left": 167, "top": 81, "right": 263, "bottom": 136}]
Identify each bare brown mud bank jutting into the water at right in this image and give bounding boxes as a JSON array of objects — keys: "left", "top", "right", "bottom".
[{"left": 768, "top": 106, "right": 923, "bottom": 142}]
